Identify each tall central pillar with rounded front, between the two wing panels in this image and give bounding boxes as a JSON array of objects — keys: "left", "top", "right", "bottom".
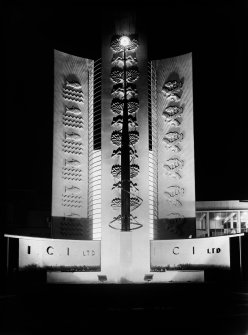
[{"left": 102, "top": 11, "right": 149, "bottom": 281}]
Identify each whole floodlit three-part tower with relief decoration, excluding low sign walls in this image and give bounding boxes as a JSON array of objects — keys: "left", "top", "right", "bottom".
[{"left": 52, "top": 10, "right": 195, "bottom": 283}]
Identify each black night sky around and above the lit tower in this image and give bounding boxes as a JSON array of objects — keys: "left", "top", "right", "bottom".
[{"left": 3, "top": 1, "right": 248, "bottom": 218}]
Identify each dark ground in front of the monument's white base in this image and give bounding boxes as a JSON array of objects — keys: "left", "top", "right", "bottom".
[{"left": 0, "top": 283, "right": 248, "bottom": 335}]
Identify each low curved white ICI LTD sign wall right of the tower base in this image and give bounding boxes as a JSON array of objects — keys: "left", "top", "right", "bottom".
[{"left": 151, "top": 236, "right": 230, "bottom": 271}]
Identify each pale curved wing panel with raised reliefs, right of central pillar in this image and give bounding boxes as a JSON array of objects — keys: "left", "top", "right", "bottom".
[{"left": 154, "top": 54, "right": 195, "bottom": 238}]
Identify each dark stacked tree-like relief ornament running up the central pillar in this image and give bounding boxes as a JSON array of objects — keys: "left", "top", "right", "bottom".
[{"left": 109, "top": 36, "right": 142, "bottom": 230}]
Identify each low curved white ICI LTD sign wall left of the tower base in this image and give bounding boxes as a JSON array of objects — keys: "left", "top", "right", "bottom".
[{"left": 19, "top": 238, "right": 101, "bottom": 271}]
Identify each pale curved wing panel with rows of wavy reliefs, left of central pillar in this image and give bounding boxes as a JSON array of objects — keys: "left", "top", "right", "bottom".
[{"left": 52, "top": 51, "right": 92, "bottom": 228}]
